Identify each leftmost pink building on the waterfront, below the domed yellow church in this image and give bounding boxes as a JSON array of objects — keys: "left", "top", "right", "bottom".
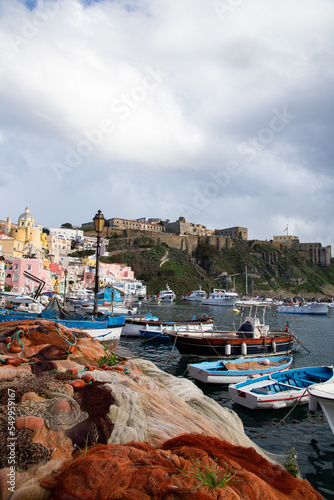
[{"left": 5, "top": 259, "right": 53, "bottom": 294}]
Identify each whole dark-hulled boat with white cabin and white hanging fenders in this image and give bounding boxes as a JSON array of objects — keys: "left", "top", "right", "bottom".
[{"left": 167, "top": 307, "right": 295, "bottom": 358}]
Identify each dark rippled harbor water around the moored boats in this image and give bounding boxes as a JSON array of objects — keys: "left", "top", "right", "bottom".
[{"left": 121, "top": 301, "right": 334, "bottom": 500}]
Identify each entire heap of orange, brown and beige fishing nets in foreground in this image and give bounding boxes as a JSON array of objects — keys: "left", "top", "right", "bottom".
[{"left": 0, "top": 321, "right": 322, "bottom": 500}]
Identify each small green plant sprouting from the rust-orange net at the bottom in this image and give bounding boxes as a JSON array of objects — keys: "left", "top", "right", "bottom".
[{"left": 183, "top": 457, "right": 239, "bottom": 489}]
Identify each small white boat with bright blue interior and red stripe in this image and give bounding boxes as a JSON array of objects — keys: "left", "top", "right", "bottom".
[{"left": 228, "top": 366, "right": 334, "bottom": 410}]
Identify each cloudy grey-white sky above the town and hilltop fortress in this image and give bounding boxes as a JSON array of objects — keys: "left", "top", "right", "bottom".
[{"left": 0, "top": 0, "right": 334, "bottom": 246}]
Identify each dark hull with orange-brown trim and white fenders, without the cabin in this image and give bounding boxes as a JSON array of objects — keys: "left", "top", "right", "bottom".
[{"left": 168, "top": 332, "right": 294, "bottom": 358}]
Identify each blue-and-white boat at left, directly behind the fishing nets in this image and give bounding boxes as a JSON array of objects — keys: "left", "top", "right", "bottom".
[{"left": 0, "top": 298, "right": 126, "bottom": 342}]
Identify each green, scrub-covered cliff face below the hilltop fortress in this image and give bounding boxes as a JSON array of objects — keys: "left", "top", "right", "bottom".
[{"left": 95, "top": 235, "right": 334, "bottom": 297}]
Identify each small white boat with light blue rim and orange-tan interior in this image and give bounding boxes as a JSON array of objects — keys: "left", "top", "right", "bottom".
[{"left": 187, "top": 356, "right": 293, "bottom": 384}]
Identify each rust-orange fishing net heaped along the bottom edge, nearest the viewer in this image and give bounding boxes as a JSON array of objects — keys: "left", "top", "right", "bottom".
[{"left": 40, "top": 435, "right": 322, "bottom": 500}]
